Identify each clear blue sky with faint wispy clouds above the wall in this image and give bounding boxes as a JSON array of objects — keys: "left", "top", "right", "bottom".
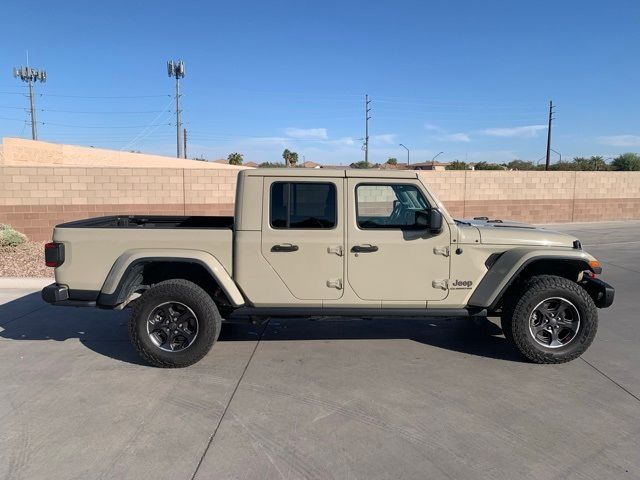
[{"left": 0, "top": 0, "right": 640, "bottom": 164}]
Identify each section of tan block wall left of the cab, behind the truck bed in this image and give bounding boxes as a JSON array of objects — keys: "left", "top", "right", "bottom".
[{"left": 0, "top": 165, "right": 238, "bottom": 240}]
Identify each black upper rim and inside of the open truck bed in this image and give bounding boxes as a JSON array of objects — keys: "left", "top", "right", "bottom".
[{"left": 57, "top": 215, "right": 233, "bottom": 229}]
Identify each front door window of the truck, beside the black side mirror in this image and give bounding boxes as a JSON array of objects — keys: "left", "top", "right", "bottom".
[{"left": 356, "top": 183, "right": 429, "bottom": 229}]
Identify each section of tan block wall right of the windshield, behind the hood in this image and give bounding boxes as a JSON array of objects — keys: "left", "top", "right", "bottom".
[{"left": 420, "top": 171, "right": 640, "bottom": 223}]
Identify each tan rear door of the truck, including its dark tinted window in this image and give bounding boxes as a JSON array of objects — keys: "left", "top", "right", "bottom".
[{"left": 261, "top": 177, "right": 344, "bottom": 300}]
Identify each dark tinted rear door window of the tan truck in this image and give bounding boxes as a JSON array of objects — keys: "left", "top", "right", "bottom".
[{"left": 269, "top": 182, "right": 337, "bottom": 229}]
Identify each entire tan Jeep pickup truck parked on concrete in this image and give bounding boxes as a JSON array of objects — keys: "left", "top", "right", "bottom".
[{"left": 42, "top": 169, "right": 614, "bottom": 367}]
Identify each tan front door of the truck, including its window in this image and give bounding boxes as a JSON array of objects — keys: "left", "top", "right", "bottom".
[{"left": 347, "top": 178, "right": 451, "bottom": 301}]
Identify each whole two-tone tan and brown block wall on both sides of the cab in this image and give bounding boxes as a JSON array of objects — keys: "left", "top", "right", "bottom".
[{"left": 0, "top": 163, "right": 640, "bottom": 240}]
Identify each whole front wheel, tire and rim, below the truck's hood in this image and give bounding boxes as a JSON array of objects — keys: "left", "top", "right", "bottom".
[{"left": 503, "top": 275, "right": 598, "bottom": 363}]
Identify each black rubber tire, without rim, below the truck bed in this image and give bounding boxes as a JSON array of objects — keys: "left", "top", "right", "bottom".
[{"left": 129, "top": 280, "right": 222, "bottom": 368}]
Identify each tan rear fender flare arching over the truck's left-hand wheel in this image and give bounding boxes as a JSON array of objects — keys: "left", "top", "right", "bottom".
[{"left": 98, "top": 249, "right": 245, "bottom": 307}]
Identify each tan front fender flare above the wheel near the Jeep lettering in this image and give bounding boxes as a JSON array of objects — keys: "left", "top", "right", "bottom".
[{"left": 468, "top": 248, "right": 595, "bottom": 310}]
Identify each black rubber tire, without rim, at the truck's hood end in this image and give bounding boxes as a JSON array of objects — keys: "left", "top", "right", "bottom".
[{"left": 503, "top": 275, "right": 598, "bottom": 363}]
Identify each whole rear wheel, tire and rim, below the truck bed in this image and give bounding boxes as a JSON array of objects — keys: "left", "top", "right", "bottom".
[{"left": 129, "top": 280, "right": 222, "bottom": 368}]
